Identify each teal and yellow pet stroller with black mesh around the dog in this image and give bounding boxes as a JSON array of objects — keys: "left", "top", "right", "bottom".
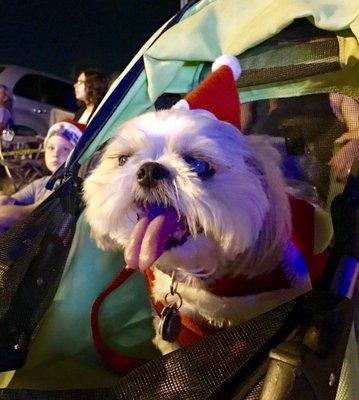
[{"left": 0, "top": 0, "right": 359, "bottom": 399}]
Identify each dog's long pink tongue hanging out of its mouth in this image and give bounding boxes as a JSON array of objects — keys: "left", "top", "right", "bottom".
[{"left": 125, "top": 205, "right": 178, "bottom": 271}]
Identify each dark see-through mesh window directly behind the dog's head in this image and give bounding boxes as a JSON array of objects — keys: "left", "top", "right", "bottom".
[{"left": 242, "top": 94, "right": 359, "bottom": 210}]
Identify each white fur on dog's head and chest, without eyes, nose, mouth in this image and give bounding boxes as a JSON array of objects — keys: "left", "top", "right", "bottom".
[{"left": 84, "top": 109, "right": 308, "bottom": 352}]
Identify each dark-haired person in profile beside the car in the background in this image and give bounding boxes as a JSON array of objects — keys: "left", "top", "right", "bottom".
[{"left": 74, "top": 68, "right": 107, "bottom": 125}]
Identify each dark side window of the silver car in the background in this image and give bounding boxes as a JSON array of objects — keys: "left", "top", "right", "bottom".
[{"left": 13, "top": 74, "right": 77, "bottom": 111}]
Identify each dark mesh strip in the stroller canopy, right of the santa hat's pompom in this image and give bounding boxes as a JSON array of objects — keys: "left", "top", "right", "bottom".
[{"left": 200, "top": 19, "right": 344, "bottom": 88}]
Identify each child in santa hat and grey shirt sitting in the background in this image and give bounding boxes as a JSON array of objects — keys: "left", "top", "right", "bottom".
[{"left": 0, "top": 120, "right": 85, "bottom": 233}]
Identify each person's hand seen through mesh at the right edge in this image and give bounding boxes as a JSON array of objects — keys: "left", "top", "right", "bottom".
[{"left": 329, "top": 138, "right": 359, "bottom": 180}]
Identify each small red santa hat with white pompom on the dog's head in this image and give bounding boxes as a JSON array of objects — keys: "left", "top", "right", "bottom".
[{"left": 175, "top": 55, "right": 242, "bottom": 128}]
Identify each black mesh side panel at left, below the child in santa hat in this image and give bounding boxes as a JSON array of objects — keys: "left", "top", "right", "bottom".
[{"left": 0, "top": 181, "right": 79, "bottom": 371}]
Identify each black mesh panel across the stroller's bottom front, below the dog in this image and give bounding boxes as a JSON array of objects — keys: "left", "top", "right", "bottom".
[{"left": 0, "top": 300, "right": 300, "bottom": 400}]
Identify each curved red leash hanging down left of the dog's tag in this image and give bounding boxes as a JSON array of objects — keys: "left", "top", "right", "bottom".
[{"left": 91, "top": 268, "right": 148, "bottom": 375}]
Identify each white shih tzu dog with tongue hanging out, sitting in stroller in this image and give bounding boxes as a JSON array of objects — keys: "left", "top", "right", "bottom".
[{"left": 84, "top": 57, "right": 311, "bottom": 353}]
